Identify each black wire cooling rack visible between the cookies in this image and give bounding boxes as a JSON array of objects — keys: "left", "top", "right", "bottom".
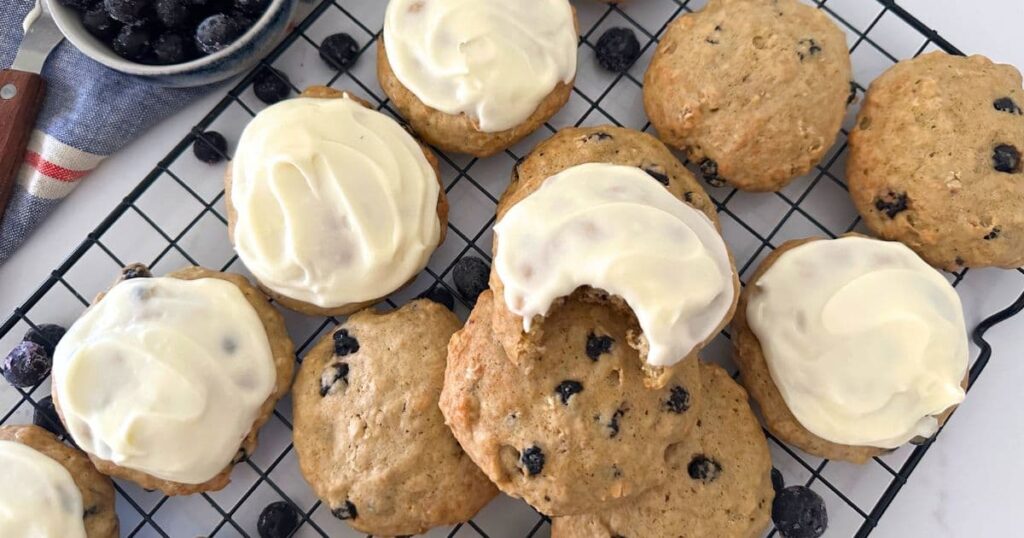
[{"left": 0, "top": 0, "right": 1024, "bottom": 538}]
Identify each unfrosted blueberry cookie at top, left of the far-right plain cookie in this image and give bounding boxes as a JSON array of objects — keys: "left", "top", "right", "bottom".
[{"left": 643, "top": 0, "right": 851, "bottom": 192}]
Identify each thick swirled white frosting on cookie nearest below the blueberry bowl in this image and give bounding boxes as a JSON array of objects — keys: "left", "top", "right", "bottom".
[{"left": 231, "top": 95, "right": 440, "bottom": 308}]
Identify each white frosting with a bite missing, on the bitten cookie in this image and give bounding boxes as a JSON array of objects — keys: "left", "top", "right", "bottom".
[{"left": 495, "top": 163, "right": 736, "bottom": 366}]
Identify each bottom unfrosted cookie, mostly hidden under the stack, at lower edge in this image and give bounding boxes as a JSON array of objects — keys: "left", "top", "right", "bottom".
[{"left": 551, "top": 364, "right": 775, "bottom": 538}]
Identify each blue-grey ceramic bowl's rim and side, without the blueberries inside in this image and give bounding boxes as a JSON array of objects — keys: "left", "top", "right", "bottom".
[{"left": 47, "top": 0, "right": 299, "bottom": 87}]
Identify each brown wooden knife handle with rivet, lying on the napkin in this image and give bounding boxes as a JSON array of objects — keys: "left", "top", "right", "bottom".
[{"left": 0, "top": 70, "right": 46, "bottom": 217}]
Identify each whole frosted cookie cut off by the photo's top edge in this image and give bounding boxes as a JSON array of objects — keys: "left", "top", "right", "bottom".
[{"left": 377, "top": 0, "right": 579, "bottom": 157}]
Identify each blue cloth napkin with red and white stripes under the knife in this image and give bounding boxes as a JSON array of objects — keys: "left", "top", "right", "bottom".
[{"left": 0, "top": 0, "right": 209, "bottom": 264}]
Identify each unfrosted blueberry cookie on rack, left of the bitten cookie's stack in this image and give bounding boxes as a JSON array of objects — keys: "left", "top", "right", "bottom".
[{"left": 292, "top": 300, "right": 498, "bottom": 536}]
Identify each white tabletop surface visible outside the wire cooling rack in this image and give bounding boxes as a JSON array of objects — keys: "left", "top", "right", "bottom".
[{"left": 0, "top": 0, "right": 1024, "bottom": 537}]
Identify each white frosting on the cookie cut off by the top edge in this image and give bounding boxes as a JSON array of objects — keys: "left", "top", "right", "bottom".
[{"left": 384, "top": 0, "right": 578, "bottom": 132}]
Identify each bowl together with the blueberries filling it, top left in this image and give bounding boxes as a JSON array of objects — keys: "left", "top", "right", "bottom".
[{"left": 43, "top": 0, "right": 300, "bottom": 87}]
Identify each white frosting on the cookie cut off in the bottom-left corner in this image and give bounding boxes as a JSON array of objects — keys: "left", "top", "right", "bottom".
[{"left": 0, "top": 441, "right": 85, "bottom": 538}]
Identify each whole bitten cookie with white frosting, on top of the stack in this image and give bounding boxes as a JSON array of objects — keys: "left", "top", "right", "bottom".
[{"left": 490, "top": 126, "right": 739, "bottom": 386}]
